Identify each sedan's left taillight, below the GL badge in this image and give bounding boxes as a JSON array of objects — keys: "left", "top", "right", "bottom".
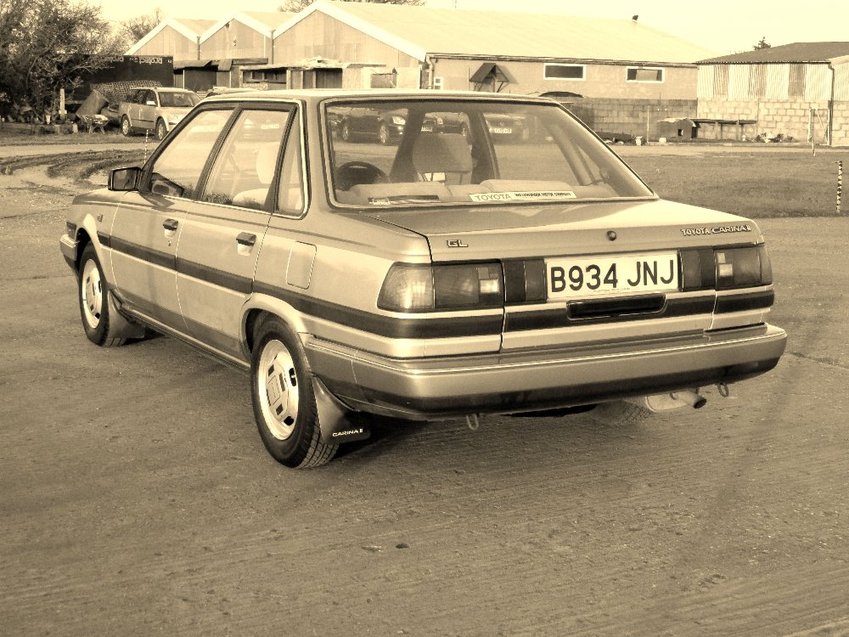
[{"left": 377, "top": 263, "right": 504, "bottom": 312}]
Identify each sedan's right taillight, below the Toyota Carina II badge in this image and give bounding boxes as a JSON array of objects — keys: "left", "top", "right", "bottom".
[{"left": 681, "top": 245, "right": 772, "bottom": 290}]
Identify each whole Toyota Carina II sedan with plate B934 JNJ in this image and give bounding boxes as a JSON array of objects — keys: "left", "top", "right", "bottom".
[{"left": 60, "top": 90, "right": 786, "bottom": 467}]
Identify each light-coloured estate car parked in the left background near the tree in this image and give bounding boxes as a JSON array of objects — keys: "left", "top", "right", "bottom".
[{"left": 118, "top": 86, "right": 200, "bottom": 140}]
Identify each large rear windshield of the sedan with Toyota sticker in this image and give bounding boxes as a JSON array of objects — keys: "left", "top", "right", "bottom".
[{"left": 325, "top": 99, "right": 653, "bottom": 207}]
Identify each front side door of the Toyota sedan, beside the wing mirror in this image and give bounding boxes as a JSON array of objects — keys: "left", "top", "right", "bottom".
[{"left": 108, "top": 107, "right": 232, "bottom": 332}]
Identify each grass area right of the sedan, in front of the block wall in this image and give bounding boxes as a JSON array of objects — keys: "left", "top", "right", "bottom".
[{"left": 623, "top": 150, "right": 849, "bottom": 218}]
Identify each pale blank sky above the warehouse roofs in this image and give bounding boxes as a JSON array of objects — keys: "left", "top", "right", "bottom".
[{"left": 96, "top": 0, "right": 849, "bottom": 55}]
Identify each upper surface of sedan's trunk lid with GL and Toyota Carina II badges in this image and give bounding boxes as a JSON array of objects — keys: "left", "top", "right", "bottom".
[{"left": 366, "top": 200, "right": 763, "bottom": 262}]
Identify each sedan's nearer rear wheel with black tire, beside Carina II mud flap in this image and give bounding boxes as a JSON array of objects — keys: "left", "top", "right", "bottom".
[{"left": 251, "top": 317, "right": 338, "bottom": 469}]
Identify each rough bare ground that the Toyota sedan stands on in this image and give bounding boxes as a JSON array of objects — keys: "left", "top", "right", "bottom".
[{"left": 0, "top": 161, "right": 849, "bottom": 636}]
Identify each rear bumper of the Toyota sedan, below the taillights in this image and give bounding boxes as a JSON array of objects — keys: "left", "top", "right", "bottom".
[{"left": 305, "top": 325, "right": 787, "bottom": 418}]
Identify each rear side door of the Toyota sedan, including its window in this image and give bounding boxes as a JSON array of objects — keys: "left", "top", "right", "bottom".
[{"left": 172, "top": 105, "right": 292, "bottom": 357}]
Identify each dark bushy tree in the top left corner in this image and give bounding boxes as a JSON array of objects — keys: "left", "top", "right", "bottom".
[{"left": 0, "top": 0, "right": 116, "bottom": 116}]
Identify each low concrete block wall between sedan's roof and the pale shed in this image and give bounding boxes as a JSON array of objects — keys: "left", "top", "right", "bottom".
[{"left": 568, "top": 97, "right": 698, "bottom": 140}]
